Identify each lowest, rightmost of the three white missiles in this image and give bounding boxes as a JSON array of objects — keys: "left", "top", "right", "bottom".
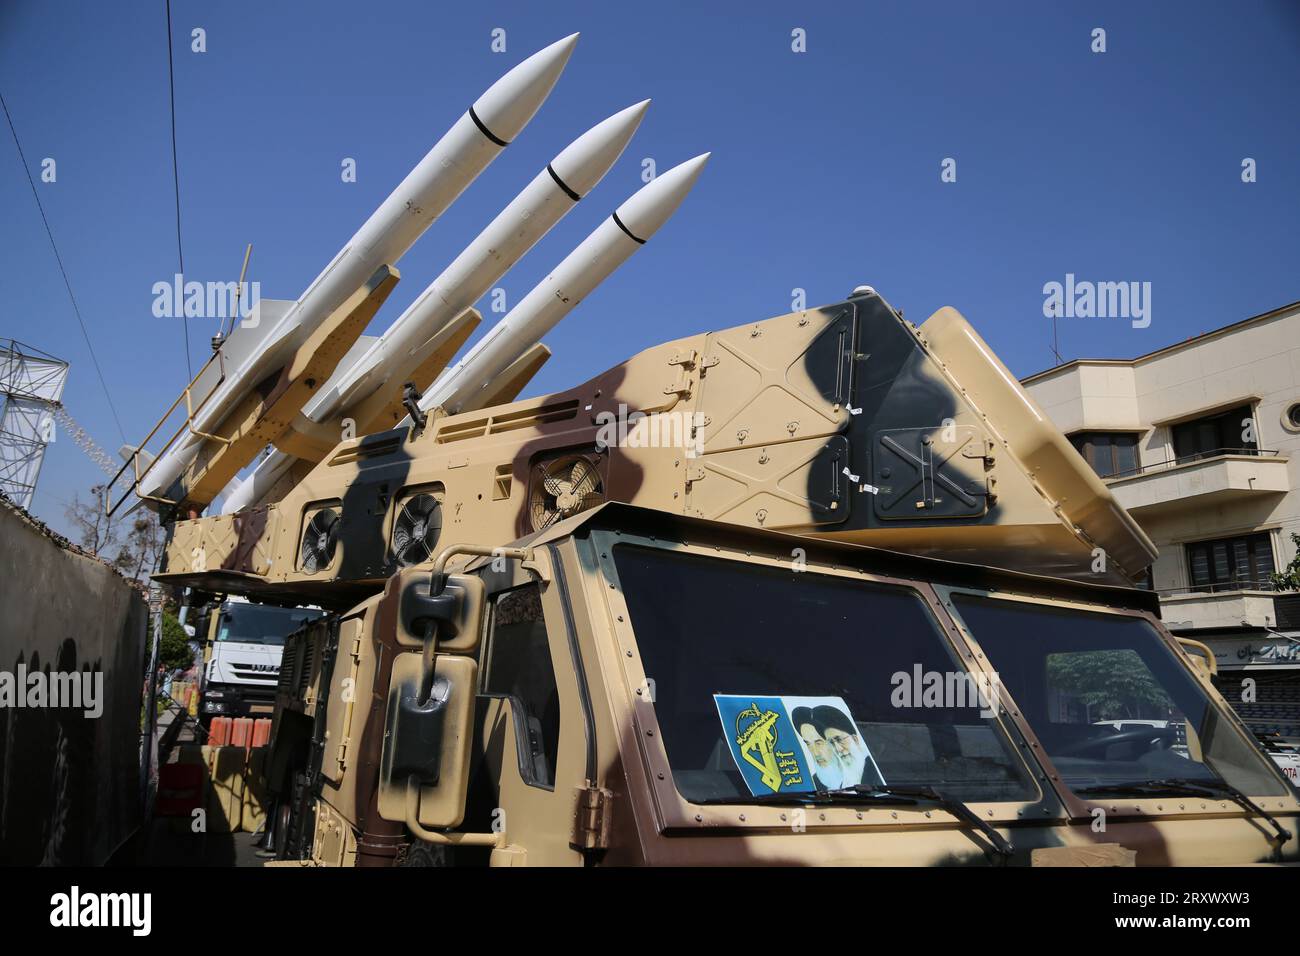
[{"left": 420, "top": 152, "right": 710, "bottom": 415}]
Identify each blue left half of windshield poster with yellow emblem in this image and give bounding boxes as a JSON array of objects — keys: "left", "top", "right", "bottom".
[{"left": 714, "top": 693, "right": 816, "bottom": 796}]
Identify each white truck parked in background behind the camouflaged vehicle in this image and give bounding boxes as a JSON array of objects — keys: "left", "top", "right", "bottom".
[{"left": 199, "top": 597, "right": 324, "bottom": 728}]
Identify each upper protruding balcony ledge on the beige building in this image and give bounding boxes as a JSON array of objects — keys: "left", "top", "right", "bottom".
[{"left": 1108, "top": 449, "right": 1291, "bottom": 519}]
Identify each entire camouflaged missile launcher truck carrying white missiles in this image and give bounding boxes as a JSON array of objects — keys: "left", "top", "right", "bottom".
[{"left": 116, "top": 38, "right": 1300, "bottom": 866}]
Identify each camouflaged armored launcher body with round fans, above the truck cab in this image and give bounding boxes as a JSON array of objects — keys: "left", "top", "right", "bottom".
[{"left": 154, "top": 287, "right": 1154, "bottom": 604}]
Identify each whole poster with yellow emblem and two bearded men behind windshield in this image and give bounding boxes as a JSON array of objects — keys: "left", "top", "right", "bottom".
[{"left": 714, "top": 693, "right": 885, "bottom": 796}]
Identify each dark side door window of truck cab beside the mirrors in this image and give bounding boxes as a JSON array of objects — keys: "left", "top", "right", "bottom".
[{"left": 482, "top": 584, "right": 560, "bottom": 790}]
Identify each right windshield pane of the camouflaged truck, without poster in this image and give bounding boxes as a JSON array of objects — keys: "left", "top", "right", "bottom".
[{"left": 953, "top": 594, "right": 1286, "bottom": 797}]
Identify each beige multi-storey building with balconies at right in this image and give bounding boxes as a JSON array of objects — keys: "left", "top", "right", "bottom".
[{"left": 1023, "top": 302, "right": 1300, "bottom": 736}]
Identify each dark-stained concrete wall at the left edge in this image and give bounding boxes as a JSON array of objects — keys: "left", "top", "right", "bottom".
[{"left": 0, "top": 499, "right": 148, "bottom": 865}]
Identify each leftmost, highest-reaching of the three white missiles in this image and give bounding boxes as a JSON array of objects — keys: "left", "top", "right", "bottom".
[{"left": 140, "top": 34, "right": 579, "bottom": 496}]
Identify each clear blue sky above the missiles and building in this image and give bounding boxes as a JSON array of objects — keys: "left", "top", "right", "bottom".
[{"left": 0, "top": 0, "right": 1300, "bottom": 538}]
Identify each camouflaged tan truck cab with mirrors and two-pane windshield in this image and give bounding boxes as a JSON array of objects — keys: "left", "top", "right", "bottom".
[{"left": 269, "top": 503, "right": 1300, "bottom": 866}]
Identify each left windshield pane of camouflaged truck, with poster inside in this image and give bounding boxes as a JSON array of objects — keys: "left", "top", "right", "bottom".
[{"left": 614, "top": 545, "right": 1037, "bottom": 803}]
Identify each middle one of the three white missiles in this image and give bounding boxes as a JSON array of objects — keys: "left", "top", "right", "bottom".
[{"left": 222, "top": 100, "right": 650, "bottom": 514}]
